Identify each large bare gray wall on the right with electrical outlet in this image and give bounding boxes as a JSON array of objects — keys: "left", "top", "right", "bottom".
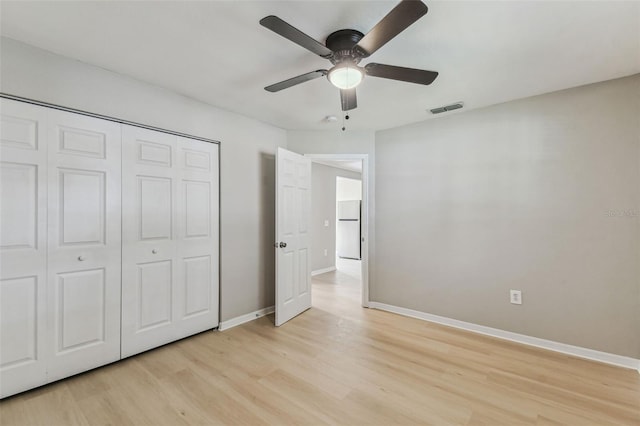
[{"left": 371, "top": 75, "right": 640, "bottom": 358}]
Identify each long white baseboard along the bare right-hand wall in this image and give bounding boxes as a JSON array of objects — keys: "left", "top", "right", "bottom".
[{"left": 369, "top": 302, "right": 640, "bottom": 373}]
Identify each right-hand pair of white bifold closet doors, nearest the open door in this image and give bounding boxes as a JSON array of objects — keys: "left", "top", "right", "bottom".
[{"left": 122, "top": 125, "right": 219, "bottom": 358}]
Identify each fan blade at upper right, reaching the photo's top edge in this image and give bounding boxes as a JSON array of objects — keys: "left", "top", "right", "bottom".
[{"left": 355, "top": 0, "right": 429, "bottom": 58}]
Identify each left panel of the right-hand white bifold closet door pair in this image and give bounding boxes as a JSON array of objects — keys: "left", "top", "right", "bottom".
[{"left": 122, "top": 126, "right": 178, "bottom": 357}]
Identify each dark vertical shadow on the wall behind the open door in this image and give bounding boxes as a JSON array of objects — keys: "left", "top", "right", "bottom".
[{"left": 258, "top": 152, "right": 276, "bottom": 306}]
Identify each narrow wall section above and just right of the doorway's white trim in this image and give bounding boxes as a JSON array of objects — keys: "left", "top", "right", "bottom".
[{"left": 287, "top": 130, "right": 376, "bottom": 288}]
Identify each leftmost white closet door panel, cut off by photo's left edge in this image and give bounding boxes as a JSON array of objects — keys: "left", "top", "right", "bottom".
[{"left": 0, "top": 99, "right": 47, "bottom": 398}]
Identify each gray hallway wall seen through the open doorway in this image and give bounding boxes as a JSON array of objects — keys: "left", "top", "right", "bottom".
[{"left": 311, "top": 163, "right": 361, "bottom": 271}]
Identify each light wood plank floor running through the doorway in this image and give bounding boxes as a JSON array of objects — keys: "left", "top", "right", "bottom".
[{"left": 0, "top": 272, "right": 640, "bottom": 426}]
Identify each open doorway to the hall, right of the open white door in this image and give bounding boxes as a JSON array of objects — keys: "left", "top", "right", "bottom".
[{"left": 305, "top": 154, "right": 369, "bottom": 307}]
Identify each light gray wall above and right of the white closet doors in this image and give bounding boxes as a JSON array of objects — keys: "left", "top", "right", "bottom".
[{"left": 0, "top": 38, "right": 287, "bottom": 321}]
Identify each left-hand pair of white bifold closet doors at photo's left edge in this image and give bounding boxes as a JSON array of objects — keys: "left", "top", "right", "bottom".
[{"left": 0, "top": 99, "right": 121, "bottom": 397}]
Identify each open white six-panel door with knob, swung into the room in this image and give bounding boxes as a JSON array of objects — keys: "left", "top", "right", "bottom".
[{"left": 276, "top": 148, "right": 311, "bottom": 326}]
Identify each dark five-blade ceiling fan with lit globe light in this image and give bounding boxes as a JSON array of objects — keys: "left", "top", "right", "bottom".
[{"left": 260, "top": 0, "right": 438, "bottom": 111}]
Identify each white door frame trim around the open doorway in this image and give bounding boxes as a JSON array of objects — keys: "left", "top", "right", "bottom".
[{"left": 304, "top": 154, "right": 369, "bottom": 308}]
